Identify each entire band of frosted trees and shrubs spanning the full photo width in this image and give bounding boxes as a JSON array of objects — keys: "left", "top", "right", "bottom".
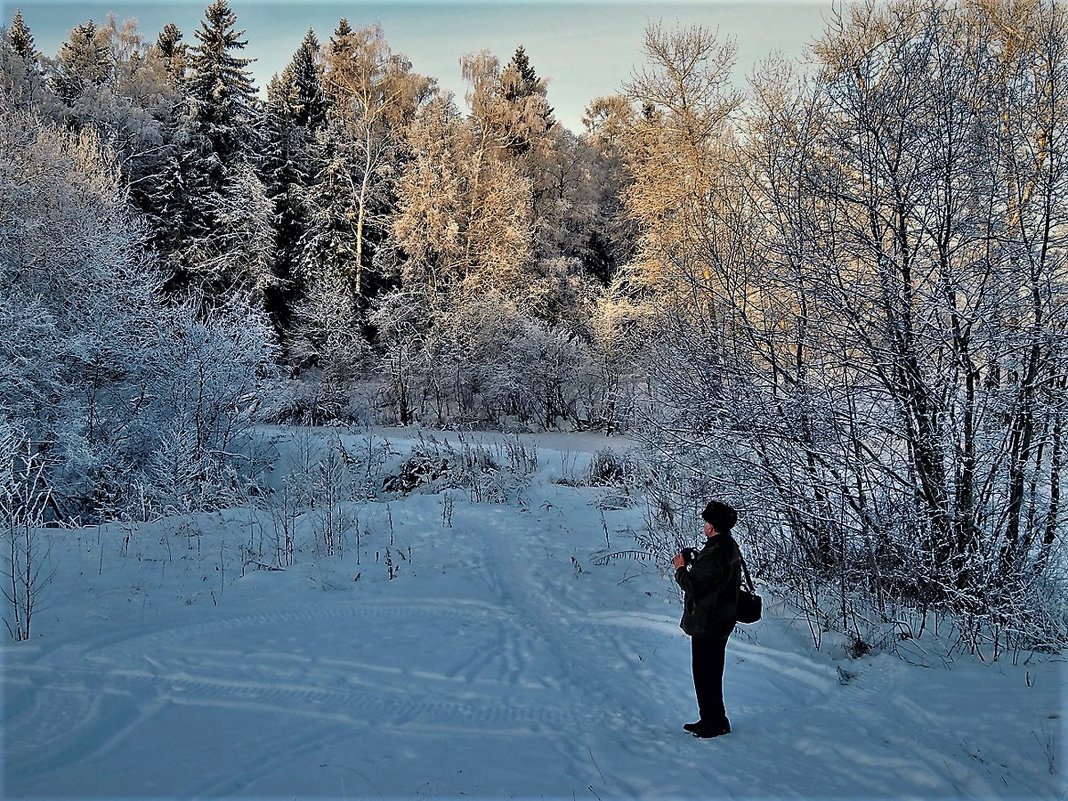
[{"left": 0, "top": 0, "right": 1068, "bottom": 655}]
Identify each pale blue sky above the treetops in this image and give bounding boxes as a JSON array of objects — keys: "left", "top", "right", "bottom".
[{"left": 12, "top": 0, "right": 832, "bottom": 131}]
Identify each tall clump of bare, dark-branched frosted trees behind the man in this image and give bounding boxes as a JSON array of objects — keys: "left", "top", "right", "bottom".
[{"left": 628, "top": 3, "right": 1068, "bottom": 656}]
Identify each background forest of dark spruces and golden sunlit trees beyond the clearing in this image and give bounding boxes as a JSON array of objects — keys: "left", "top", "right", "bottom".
[{"left": 3, "top": 0, "right": 634, "bottom": 440}]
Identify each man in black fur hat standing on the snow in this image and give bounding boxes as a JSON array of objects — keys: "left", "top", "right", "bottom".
[{"left": 674, "top": 501, "right": 741, "bottom": 737}]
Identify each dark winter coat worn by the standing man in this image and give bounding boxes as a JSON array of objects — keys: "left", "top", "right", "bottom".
[{"left": 675, "top": 534, "right": 741, "bottom": 637}]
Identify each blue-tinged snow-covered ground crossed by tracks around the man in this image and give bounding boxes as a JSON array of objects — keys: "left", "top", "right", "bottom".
[{"left": 0, "top": 433, "right": 1068, "bottom": 799}]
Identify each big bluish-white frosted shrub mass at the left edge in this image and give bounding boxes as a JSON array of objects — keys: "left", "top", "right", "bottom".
[{"left": 0, "top": 108, "right": 272, "bottom": 518}]
